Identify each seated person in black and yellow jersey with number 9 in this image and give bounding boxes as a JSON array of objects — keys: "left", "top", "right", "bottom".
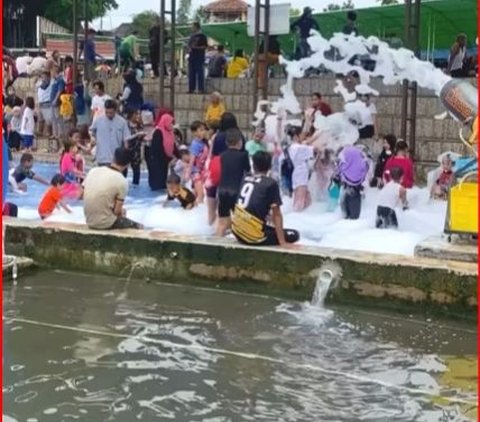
[{"left": 232, "top": 151, "right": 300, "bottom": 246}]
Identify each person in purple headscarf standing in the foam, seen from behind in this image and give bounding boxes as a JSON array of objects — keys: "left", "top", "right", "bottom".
[{"left": 338, "top": 146, "right": 369, "bottom": 220}]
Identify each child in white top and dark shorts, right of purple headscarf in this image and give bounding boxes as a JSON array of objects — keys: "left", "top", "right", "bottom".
[{"left": 375, "top": 167, "right": 407, "bottom": 229}]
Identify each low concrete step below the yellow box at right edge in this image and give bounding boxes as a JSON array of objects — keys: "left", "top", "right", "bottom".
[{"left": 415, "top": 236, "right": 478, "bottom": 262}]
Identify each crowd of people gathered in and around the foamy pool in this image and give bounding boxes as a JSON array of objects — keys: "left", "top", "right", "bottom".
[{"left": 4, "top": 54, "right": 454, "bottom": 246}]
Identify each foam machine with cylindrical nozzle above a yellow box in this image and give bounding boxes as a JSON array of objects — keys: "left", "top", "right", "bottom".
[{"left": 440, "top": 79, "right": 478, "bottom": 241}]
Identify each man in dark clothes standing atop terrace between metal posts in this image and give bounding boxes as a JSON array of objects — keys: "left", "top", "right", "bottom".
[{"left": 188, "top": 22, "right": 208, "bottom": 94}]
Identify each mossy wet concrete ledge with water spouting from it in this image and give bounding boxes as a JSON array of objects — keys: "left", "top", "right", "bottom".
[{"left": 5, "top": 218, "right": 478, "bottom": 320}]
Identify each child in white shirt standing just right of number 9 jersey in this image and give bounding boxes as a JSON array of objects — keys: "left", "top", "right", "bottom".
[{"left": 284, "top": 126, "right": 314, "bottom": 212}]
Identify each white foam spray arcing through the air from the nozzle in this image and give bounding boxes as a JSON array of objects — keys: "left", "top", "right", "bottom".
[{"left": 254, "top": 32, "right": 462, "bottom": 150}]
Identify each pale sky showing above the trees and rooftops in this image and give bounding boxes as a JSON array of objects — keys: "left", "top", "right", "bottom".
[{"left": 93, "top": 0, "right": 378, "bottom": 30}]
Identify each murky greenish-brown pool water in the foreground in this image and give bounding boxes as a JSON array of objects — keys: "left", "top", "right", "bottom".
[{"left": 3, "top": 272, "right": 477, "bottom": 422}]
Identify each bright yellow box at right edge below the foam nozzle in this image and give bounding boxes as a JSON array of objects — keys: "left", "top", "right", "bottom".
[{"left": 448, "top": 182, "right": 478, "bottom": 234}]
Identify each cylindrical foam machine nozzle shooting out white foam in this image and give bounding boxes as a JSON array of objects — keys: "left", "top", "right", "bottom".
[{"left": 440, "top": 79, "right": 478, "bottom": 154}]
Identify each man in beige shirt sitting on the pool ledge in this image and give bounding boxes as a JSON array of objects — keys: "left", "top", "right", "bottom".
[{"left": 83, "top": 148, "right": 143, "bottom": 230}]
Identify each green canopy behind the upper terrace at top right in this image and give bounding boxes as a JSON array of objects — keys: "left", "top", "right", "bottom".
[{"left": 178, "top": 0, "right": 477, "bottom": 54}]
